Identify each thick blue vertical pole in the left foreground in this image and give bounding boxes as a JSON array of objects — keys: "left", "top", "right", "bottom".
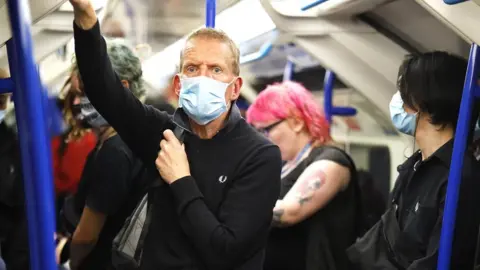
[{"left": 7, "top": 0, "right": 56, "bottom": 270}]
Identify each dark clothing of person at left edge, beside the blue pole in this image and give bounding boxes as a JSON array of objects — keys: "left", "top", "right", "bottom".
[{"left": 0, "top": 123, "right": 30, "bottom": 270}]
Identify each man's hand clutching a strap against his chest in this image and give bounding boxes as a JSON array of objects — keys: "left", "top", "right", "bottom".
[{"left": 155, "top": 129, "right": 190, "bottom": 184}]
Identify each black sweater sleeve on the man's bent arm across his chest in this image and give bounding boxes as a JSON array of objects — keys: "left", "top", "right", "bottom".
[{"left": 170, "top": 146, "right": 282, "bottom": 267}]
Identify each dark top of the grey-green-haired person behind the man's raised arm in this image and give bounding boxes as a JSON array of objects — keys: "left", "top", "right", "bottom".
[{"left": 73, "top": 135, "right": 143, "bottom": 270}]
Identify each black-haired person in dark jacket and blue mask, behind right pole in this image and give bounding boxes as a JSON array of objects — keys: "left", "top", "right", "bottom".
[{"left": 347, "top": 52, "right": 480, "bottom": 270}]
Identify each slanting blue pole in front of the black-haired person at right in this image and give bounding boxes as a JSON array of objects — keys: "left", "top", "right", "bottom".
[{"left": 437, "top": 44, "right": 480, "bottom": 270}]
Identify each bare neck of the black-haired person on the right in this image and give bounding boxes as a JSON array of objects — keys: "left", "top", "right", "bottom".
[{"left": 415, "top": 124, "right": 453, "bottom": 160}]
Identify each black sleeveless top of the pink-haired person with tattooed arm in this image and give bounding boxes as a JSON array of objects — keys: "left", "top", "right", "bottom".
[{"left": 264, "top": 146, "right": 361, "bottom": 270}]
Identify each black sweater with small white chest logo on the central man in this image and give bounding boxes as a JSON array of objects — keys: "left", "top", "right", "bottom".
[{"left": 74, "top": 19, "right": 281, "bottom": 270}]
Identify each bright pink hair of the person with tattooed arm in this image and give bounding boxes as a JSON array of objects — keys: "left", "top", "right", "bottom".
[{"left": 247, "top": 81, "right": 331, "bottom": 143}]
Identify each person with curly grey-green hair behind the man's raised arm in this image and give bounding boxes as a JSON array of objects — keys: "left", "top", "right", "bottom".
[{"left": 57, "top": 40, "right": 149, "bottom": 270}]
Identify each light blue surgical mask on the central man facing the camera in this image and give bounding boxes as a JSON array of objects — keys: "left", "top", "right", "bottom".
[{"left": 178, "top": 76, "right": 234, "bottom": 125}]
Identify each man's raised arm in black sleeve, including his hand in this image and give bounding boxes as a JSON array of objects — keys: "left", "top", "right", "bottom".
[{"left": 70, "top": 0, "right": 169, "bottom": 165}]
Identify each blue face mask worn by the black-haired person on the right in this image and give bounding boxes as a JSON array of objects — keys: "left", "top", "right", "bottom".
[{"left": 390, "top": 92, "right": 417, "bottom": 136}]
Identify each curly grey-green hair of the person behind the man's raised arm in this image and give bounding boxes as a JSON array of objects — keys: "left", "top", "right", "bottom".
[{"left": 72, "top": 39, "right": 146, "bottom": 101}]
